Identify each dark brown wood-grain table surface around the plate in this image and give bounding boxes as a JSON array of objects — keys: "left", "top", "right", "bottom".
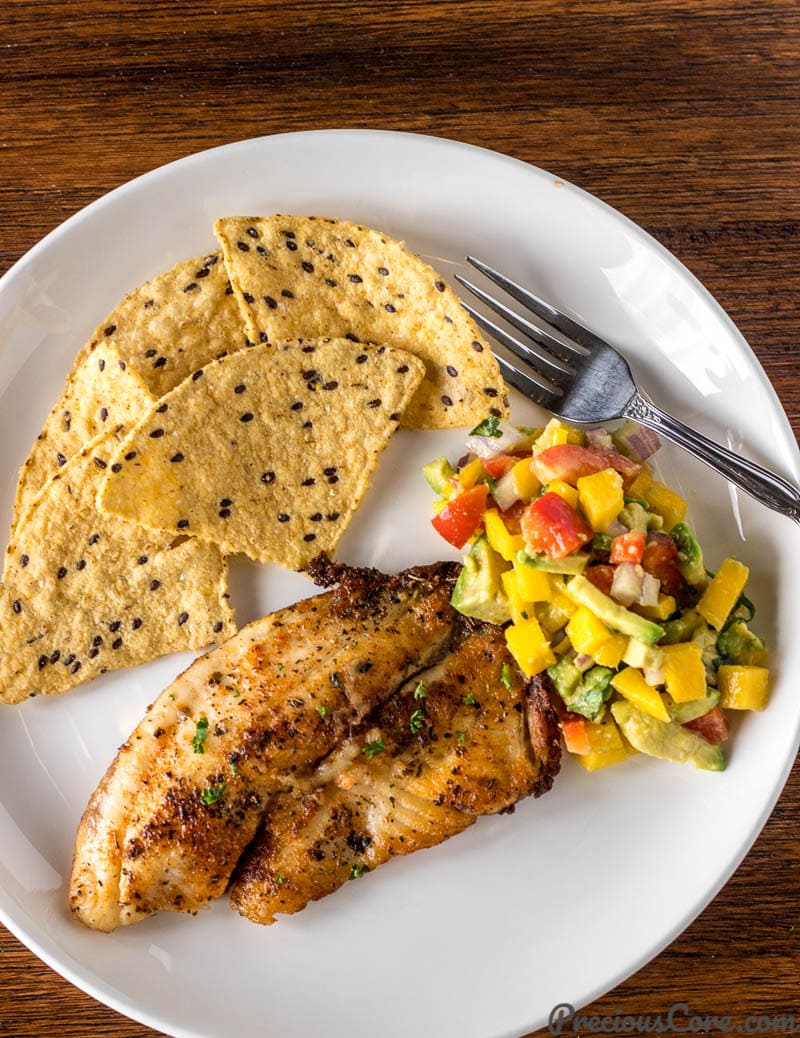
[{"left": 0, "top": 0, "right": 800, "bottom": 1038}]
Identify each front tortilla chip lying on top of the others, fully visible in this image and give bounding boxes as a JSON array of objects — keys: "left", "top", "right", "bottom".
[{"left": 100, "top": 339, "right": 423, "bottom": 569}]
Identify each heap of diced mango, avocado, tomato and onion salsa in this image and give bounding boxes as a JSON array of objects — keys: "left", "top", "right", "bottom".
[{"left": 423, "top": 417, "right": 769, "bottom": 771}]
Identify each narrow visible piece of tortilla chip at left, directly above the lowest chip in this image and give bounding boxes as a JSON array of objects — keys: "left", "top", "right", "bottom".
[{"left": 11, "top": 342, "right": 154, "bottom": 537}]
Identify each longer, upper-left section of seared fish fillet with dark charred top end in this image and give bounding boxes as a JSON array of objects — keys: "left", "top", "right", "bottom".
[{"left": 70, "top": 557, "right": 461, "bottom": 931}]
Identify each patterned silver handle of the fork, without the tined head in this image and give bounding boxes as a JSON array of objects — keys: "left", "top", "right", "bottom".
[{"left": 623, "top": 392, "right": 800, "bottom": 523}]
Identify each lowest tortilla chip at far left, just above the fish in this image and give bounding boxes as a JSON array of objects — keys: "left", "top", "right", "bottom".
[{"left": 0, "top": 431, "right": 236, "bottom": 703}]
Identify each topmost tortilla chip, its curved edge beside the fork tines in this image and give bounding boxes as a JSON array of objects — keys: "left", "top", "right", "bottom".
[{"left": 215, "top": 216, "right": 508, "bottom": 429}]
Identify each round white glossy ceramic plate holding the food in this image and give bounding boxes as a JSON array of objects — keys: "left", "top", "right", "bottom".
[{"left": 0, "top": 131, "right": 800, "bottom": 1038}]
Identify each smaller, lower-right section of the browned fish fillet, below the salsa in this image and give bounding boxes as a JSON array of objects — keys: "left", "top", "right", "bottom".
[{"left": 230, "top": 625, "right": 560, "bottom": 923}]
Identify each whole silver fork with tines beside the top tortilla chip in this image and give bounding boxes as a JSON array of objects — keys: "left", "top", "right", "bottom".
[{"left": 456, "top": 256, "right": 800, "bottom": 523}]
